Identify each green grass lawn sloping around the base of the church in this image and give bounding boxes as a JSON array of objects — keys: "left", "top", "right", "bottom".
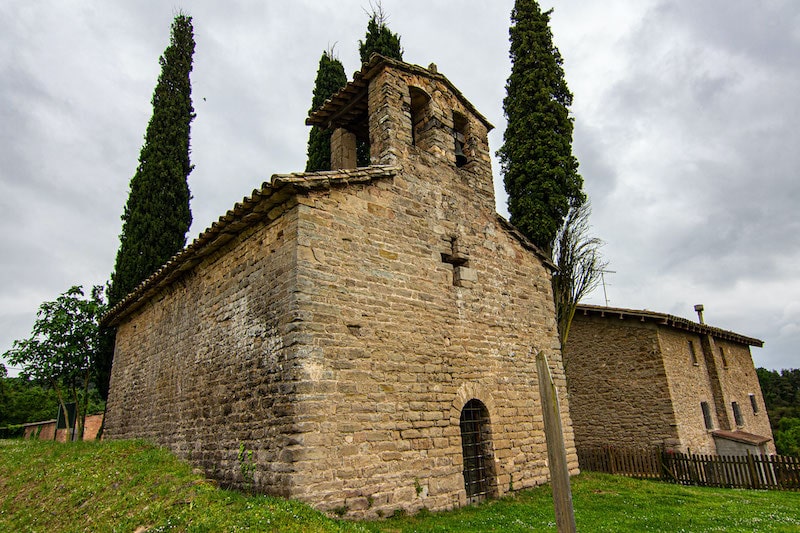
[{"left": 0, "top": 440, "right": 800, "bottom": 533}]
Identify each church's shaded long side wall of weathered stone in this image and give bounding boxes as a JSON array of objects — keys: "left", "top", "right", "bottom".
[{"left": 105, "top": 211, "right": 304, "bottom": 495}]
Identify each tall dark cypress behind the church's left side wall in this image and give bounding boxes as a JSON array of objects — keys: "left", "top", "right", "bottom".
[{"left": 97, "top": 13, "right": 195, "bottom": 398}]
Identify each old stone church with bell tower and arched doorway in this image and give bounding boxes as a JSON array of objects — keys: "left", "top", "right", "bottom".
[{"left": 104, "top": 56, "right": 578, "bottom": 517}]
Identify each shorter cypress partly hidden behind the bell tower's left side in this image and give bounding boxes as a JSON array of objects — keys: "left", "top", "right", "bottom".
[{"left": 306, "top": 50, "right": 347, "bottom": 172}]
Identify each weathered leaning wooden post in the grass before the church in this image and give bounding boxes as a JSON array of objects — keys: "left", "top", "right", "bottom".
[{"left": 536, "top": 351, "right": 576, "bottom": 533}]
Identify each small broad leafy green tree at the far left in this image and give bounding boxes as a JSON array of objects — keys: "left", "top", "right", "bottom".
[{"left": 3, "top": 286, "right": 106, "bottom": 439}]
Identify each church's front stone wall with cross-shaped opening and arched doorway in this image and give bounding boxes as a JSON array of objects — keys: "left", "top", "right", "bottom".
[{"left": 282, "top": 65, "right": 577, "bottom": 516}]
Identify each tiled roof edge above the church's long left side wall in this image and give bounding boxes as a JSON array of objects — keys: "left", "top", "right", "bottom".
[{"left": 102, "top": 165, "right": 399, "bottom": 326}]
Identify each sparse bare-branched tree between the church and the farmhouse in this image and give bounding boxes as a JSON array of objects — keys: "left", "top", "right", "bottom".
[{"left": 553, "top": 201, "right": 608, "bottom": 347}]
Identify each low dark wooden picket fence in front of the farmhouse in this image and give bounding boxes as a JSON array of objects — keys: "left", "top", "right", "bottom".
[{"left": 578, "top": 447, "right": 800, "bottom": 490}]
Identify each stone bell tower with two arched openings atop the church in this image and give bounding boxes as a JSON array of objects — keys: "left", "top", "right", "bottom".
[{"left": 306, "top": 54, "right": 494, "bottom": 209}]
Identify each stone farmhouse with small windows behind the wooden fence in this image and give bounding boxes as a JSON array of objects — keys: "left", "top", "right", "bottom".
[{"left": 564, "top": 305, "right": 775, "bottom": 455}]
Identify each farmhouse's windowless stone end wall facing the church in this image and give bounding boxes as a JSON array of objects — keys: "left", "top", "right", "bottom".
[{"left": 564, "top": 311, "right": 678, "bottom": 448}]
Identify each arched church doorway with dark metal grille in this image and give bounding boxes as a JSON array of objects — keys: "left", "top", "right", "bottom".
[{"left": 460, "top": 398, "right": 496, "bottom": 503}]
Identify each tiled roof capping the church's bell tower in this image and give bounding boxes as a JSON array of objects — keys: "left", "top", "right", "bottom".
[{"left": 306, "top": 54, "right": 494, "bottom": 131}]
